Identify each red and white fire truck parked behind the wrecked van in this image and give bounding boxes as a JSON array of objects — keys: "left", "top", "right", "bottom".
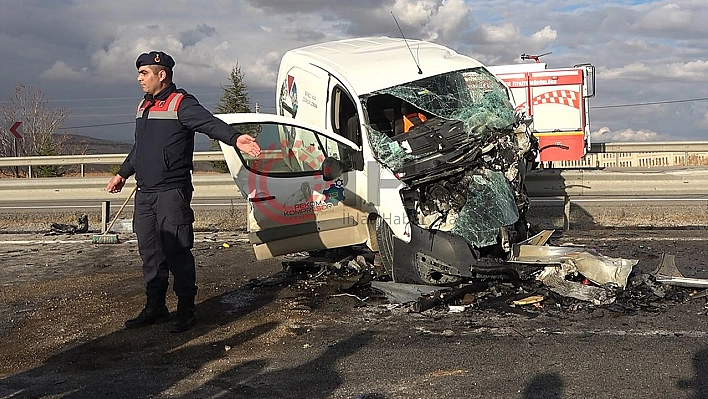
[{"left": 488, "top": 54, "right": 595, "bottom": 162}]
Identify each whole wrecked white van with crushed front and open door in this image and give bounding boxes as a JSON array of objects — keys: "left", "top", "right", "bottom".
[{"left": 219, "top": 37, "right": 538, "bottom": 285}]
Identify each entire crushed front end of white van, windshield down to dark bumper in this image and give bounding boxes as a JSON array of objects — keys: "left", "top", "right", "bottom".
[{"left": 362, "top": 67, "right": 538, "bottom": 284}]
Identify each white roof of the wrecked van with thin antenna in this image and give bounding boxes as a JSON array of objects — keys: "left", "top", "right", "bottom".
[{"left": 284, "top": 36, "right": 482, "bottom": 95}]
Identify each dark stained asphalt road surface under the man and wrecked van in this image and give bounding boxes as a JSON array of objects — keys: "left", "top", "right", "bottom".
[{"left": 0, "top": 229, "right": 708, "bottom": 399}]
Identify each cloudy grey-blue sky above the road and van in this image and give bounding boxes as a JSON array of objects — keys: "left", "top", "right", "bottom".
[{"left": 0, "top": 0, "right": 708, "bottom": 147}]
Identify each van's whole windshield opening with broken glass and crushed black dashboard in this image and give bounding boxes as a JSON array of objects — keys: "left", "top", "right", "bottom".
[{"left": 362, "top": 68, "right": 518, "bottom": 183}]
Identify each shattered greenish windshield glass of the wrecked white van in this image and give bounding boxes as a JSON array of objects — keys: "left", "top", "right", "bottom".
[{"left": 363, "top": 68, "right": 516, "bottom": 169}]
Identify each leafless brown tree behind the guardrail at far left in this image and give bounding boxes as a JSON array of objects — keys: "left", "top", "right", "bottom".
[{"left": 0, "top": 84, "right": 69, "bottom": 177}]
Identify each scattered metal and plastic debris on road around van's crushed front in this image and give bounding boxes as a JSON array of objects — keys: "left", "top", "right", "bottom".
[{"left": 283, "top": 230, "right": 708, "bottom": 316}]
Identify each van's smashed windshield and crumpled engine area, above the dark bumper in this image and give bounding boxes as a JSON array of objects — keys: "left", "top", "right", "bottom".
[{"left": 362, "top": 67, "right": 538, "bottom": 252}]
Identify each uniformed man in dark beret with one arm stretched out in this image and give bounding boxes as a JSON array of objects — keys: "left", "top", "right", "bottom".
[{"left": 106, "top": 51, "right": 261, "bottom": 332}]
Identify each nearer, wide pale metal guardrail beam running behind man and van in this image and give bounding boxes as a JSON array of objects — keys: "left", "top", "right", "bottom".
[{"left": 0, "top": 167, "right": 708, "bottom": 201}]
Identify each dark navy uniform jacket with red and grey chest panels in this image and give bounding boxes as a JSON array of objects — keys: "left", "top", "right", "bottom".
[{"left": 118, "top": 83, "right": 240, "bottom": 192}]
